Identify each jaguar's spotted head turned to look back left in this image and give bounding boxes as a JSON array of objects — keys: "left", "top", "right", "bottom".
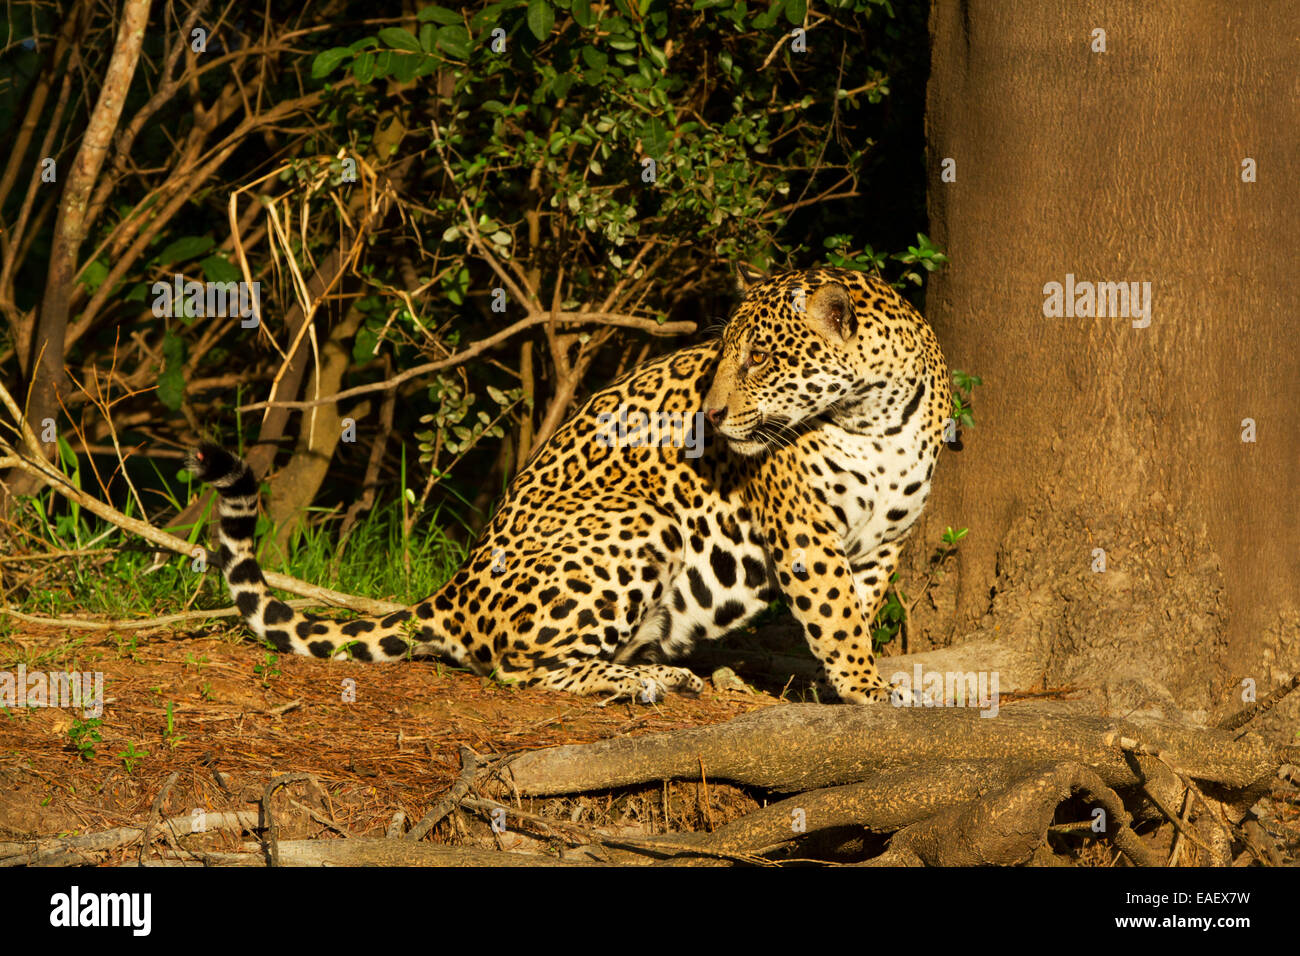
[{"left": 705, "top": 269, "right": 862, "bottom": 455}]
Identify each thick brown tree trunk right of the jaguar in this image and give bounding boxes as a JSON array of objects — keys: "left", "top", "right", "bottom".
[{"left": 913, "top": 0, "right": 1300, "bottom": 728}]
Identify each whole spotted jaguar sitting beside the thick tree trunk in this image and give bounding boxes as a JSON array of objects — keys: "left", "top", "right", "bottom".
[{"left": 190, "top": 269, "right": 952, "bottom": 702}]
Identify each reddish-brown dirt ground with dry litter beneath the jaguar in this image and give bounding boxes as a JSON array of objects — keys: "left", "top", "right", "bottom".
[{"left": 0, "top": 616, "right": 798, "bottom": 865}]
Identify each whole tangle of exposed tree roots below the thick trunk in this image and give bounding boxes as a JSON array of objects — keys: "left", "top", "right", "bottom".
[{"left": 488, "top": 701, "right": 1296, "bottom": 866}]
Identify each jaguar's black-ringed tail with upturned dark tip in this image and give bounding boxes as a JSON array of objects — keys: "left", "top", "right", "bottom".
[{"left": 186, "top": 442, "right": 426, "bottom": 661}]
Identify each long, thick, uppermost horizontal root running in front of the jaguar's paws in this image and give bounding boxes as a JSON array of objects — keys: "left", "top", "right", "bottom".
[{"left": 510, "top": 701, "right": 1295, "bottom": 796}]
